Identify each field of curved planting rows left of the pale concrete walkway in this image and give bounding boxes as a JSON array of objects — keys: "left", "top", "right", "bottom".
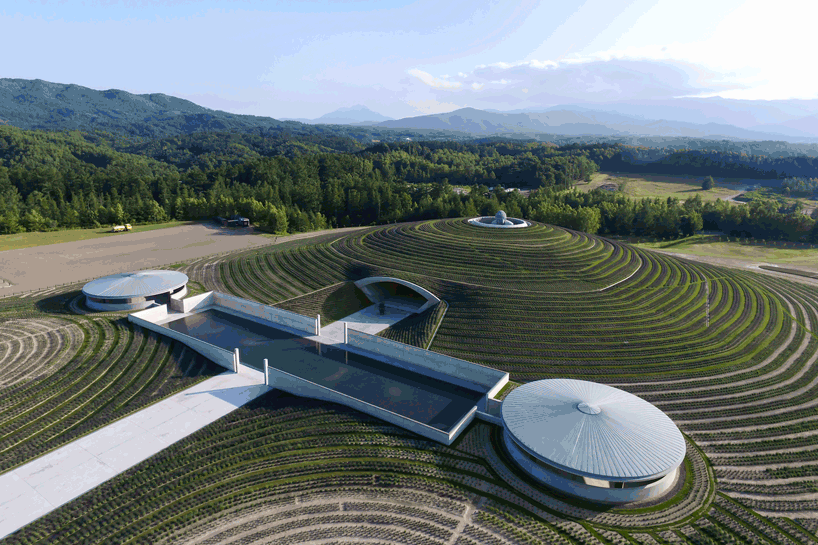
[{"left": 0, "top": 289, "right": 218, "bottom": 472}]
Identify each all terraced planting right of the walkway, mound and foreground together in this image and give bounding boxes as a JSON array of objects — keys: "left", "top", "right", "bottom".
[{"left": 1, "top": 220, "right": 818, "bottom": 544}]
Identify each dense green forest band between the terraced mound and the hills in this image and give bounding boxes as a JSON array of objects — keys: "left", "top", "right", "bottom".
[{"left": 0, "top": 127, "right": 818, "bottom": 241}]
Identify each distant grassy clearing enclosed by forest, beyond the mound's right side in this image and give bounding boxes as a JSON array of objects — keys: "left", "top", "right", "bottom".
[{"left": 576, "top": 172, "right": 757, "bottom": 202}]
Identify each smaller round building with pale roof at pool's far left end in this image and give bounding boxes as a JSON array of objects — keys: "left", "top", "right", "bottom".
[{"left": 82, "top": 271, "right": 188, "bottom": 310}]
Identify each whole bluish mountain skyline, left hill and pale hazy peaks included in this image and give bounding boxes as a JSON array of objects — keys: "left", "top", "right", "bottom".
[{"left": 0, "top": 79, "right": 818, "bottom": 142}]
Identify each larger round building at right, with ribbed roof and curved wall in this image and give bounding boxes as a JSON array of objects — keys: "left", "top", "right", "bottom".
[{"left": 501, "top": 379, "right": 686, "bottom": 504}]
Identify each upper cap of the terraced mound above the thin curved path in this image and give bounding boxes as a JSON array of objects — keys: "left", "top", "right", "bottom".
[{"left": 331, "top": 220, "right": 639, "bottom": 291}]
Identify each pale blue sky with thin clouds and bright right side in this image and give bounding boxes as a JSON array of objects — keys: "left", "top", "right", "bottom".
[{"left": 0, "top": 0, "right": 818, "bottom": 119}]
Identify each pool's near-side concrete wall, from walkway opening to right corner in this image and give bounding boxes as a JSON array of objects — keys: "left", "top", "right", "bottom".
[{"left": 267, "top": 367, "right": 466, "bottom": 445}]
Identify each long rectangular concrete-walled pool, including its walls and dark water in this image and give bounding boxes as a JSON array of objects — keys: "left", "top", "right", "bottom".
[{"left": 128, "top": 292, "right": 509, "bottom": 445}]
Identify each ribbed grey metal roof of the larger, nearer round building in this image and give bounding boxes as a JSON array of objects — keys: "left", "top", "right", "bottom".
[{"left": 502, "top": 379, "right": 686, "bottom": 481}]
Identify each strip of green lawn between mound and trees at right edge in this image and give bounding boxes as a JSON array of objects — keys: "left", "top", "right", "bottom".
[{"left": 634, "top": 235, "right": 818, "bottom": 271}]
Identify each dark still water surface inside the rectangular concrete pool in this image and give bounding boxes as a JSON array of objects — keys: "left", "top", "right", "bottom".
[{"left": 165, "top": 309, "right": 483, "bottom": 431}]
